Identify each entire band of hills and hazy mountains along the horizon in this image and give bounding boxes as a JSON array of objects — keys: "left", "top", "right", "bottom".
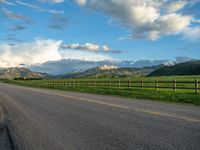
[{"left": 0, "top": 60, "right": 200, "bottom": 79}]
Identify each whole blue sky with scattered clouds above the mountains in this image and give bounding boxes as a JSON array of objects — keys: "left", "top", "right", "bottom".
[{"left": 0, "top": 0, "right": 200, "bottom": 67}]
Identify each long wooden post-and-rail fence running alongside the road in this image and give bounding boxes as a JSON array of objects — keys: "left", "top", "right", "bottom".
[{"left": 1, "top": 79, "right": 200, "bottom": 93}]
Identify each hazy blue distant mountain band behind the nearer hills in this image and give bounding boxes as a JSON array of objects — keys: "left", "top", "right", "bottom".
[{"left": 27, "top": 57, "right": 192, "bottom": 75}]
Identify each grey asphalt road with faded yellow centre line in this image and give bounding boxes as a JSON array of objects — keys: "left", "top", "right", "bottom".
[{"left": 0, "top": 84, "right": 200, "bottom": 150}]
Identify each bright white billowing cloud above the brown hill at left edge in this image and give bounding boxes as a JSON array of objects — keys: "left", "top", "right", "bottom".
[{"left": 0, "top": 39, "right": 61, "bottom": 67}]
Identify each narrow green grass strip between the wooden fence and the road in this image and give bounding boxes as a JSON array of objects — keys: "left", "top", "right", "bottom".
[{"left": 4, "top": 81, "right": 200, "bottom": 105}]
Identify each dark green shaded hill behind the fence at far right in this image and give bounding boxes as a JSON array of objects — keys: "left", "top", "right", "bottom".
[{"left": 149, "top": 61, "right": 200, "bottom": 76}]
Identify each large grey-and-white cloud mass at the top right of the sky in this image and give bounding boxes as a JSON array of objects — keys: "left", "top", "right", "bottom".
[{"left": 74, "top": 0, "right": 196, "bottom": 40}]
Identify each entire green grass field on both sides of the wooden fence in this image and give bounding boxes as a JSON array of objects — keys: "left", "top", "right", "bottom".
[{"left": 2, "top": 76, "right": 200, "bottom": 105}]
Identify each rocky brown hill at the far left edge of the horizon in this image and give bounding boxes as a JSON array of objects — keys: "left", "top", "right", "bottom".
[{"left": 0, "top": 68, "right": 49, "bottom": 79}]
